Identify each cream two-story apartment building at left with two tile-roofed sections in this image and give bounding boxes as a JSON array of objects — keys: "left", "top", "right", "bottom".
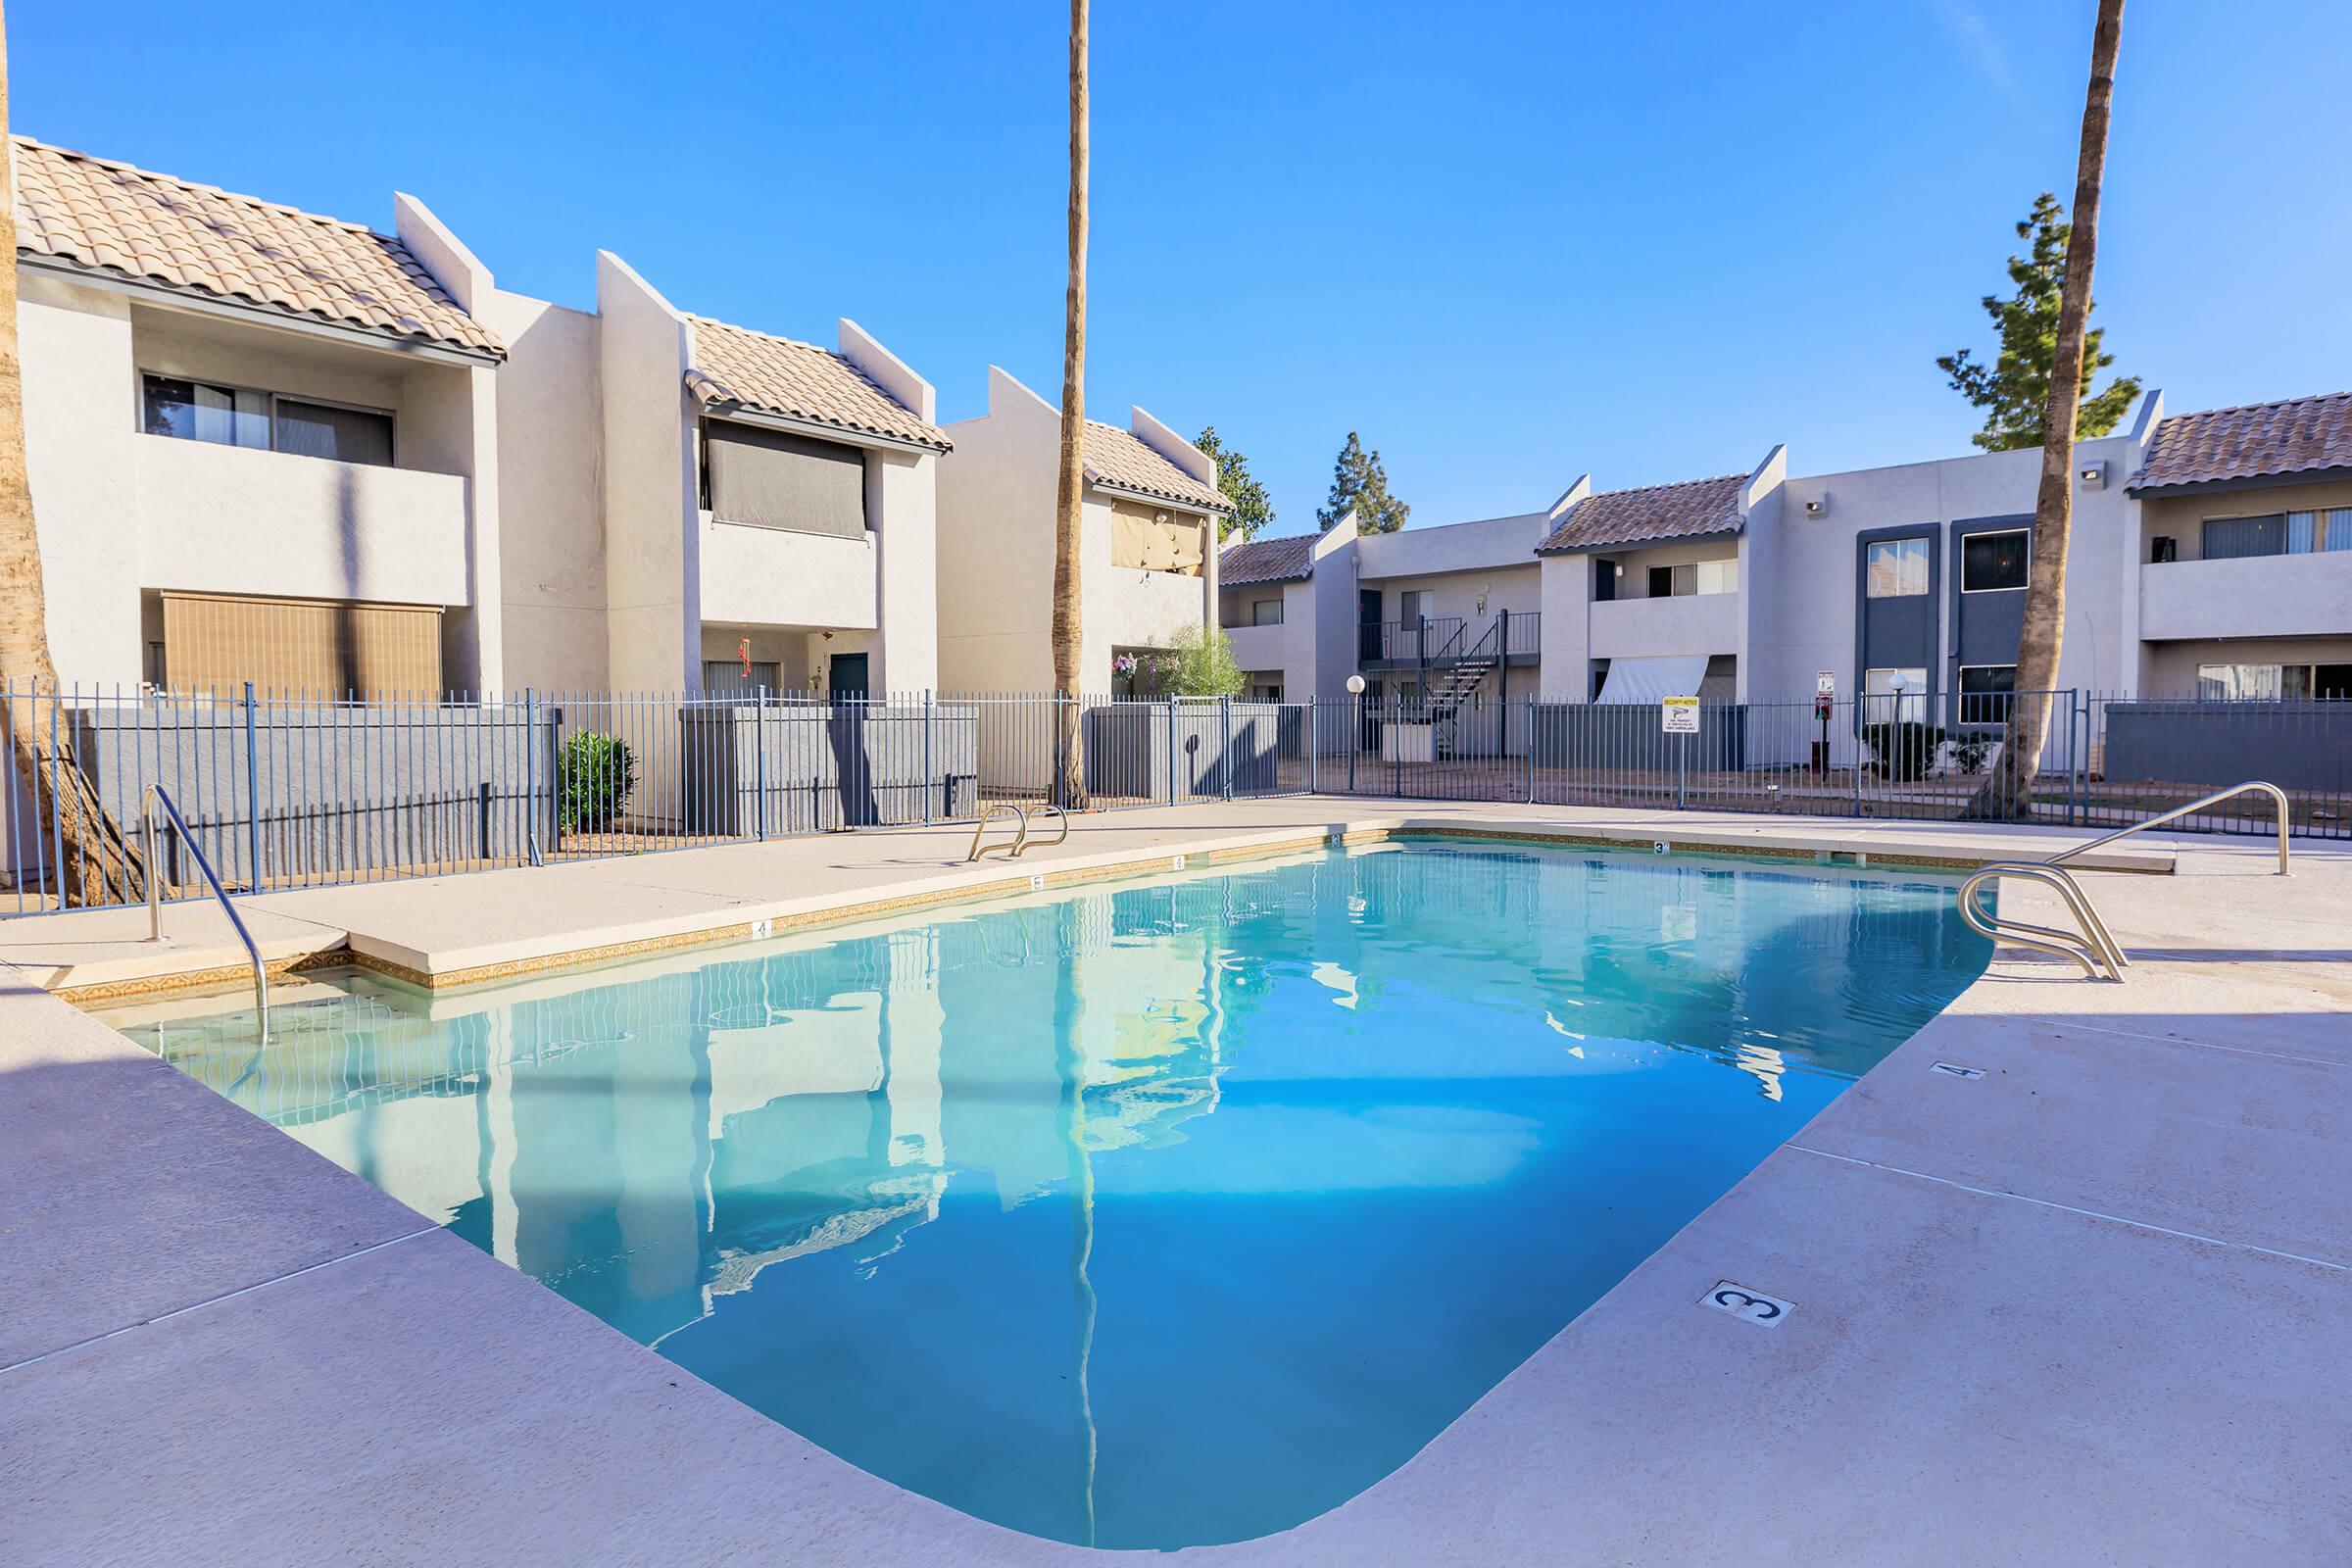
[{"left": 14, "top": 139, "right": 951, "bottom": 698}]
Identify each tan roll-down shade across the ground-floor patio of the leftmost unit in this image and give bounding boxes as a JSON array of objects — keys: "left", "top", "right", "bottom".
[{"left": 163, "top": 592, "right": 442, "bottom": 698}]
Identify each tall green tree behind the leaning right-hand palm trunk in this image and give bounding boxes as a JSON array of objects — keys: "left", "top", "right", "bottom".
[{"left": 1936, "top": 190, "right": 2140, "bottom": 452}]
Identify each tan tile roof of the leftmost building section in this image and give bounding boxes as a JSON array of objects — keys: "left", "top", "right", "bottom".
[{"left": 12, "top": 136, "right": 506, "bottom": 355}]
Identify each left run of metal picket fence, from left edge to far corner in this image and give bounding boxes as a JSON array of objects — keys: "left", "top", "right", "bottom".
[{"left": 0, "top": 689, "right": 1310, "bottom": 914}]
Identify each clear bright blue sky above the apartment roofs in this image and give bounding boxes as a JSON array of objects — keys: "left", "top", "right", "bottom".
[{"left": 7, "top": 0, "right": 2352, "bottom": 531}]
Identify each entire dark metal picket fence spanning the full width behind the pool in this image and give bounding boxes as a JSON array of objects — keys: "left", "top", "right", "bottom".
[{"left": 0, "top": 691, "right": 2352, "bottom": 914}]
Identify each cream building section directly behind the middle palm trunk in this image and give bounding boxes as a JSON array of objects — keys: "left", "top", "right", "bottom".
[{"left": 939, "top": 367, "right": 1233, "bottom": 694}]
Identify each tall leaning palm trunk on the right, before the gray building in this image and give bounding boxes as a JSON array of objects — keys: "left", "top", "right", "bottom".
[{"left": 1964, "top": 0, "right": 2124, "bottom": 818}]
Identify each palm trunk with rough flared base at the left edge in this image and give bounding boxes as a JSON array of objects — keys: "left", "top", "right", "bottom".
[{"left": 0, "top": 0, "right": 141, "bottom": 906}]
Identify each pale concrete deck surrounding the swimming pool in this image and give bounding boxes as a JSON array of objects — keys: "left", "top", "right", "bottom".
[{"left": 0, "top": 800, "right": 2352, "bottom": 1566}]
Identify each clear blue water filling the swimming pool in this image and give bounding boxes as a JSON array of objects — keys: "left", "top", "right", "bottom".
[{"left": 131, "top": 844, "right": 1987, "bottom": 1546}]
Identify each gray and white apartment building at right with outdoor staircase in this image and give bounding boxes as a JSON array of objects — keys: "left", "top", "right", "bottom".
[{"left": 1223, "top": 393, "right": 2352, "bottom": 743}]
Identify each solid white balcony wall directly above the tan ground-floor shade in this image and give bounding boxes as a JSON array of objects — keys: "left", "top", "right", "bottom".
[{"left": 131, "top": 435, "right": 472, "bottom": 604}]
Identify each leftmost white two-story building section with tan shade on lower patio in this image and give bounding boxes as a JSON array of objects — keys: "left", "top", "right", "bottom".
[{"left": 12, "top": 139, "right": 508, "bottom": 696}]
